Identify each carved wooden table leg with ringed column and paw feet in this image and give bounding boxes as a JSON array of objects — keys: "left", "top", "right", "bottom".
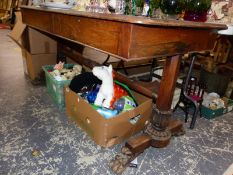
[{"left": 110, "top": 55, "right": 183, "bottom": 173}]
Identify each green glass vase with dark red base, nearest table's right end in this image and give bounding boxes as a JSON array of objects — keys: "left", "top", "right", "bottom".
[{"left": 184, "top": 0, "right": 212, "bottom": 22}]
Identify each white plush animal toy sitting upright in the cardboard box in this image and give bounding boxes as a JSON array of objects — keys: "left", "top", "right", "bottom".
[{"left": 92, "top": 65, "right": 114, "bottom": 108}]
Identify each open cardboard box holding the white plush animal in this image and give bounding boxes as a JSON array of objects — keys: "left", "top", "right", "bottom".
[{"left": 65, "top": 87, "right": 152, "bottom": 147}]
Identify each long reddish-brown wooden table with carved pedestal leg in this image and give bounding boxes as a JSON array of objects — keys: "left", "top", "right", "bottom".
[{"left": 21, "top": 6, "right": 227, "bottom": 171}]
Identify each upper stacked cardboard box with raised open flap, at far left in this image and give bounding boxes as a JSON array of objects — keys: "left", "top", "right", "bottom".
[{"left": 9, "top": 12, "right": 57, "bottom": 54}]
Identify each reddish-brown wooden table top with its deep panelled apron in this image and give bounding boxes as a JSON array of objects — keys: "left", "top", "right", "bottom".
[{"left": 21, "top": 6, "right": 227, "bottom": 61}]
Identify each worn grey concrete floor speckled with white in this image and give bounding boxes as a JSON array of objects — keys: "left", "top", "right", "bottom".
[{"left": 0, "top": 29, "right": 233, "bottom": 175}]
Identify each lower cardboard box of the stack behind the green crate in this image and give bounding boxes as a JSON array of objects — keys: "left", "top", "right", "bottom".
[{"left": 22, "top": 49, "right": 57, "bottom": 80}]
